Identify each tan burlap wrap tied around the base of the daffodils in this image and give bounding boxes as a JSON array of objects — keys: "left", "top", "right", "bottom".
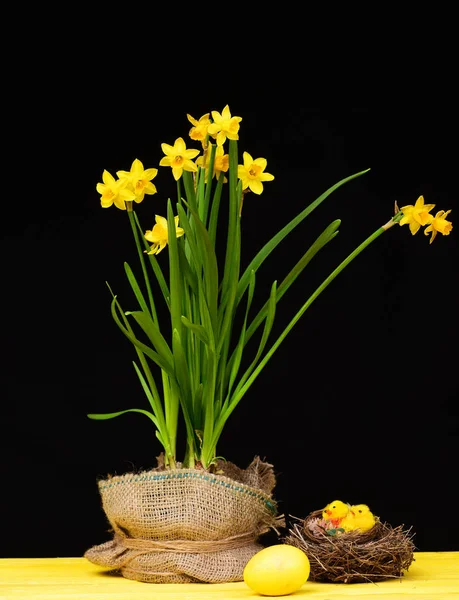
[{"left": 85, "top": 457, "right": 285, "bottom": 583}]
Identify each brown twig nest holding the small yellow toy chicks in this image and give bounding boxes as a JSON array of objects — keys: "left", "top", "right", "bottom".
[{"left": 284, "top": 510, "right": 415, "bottom": 583}]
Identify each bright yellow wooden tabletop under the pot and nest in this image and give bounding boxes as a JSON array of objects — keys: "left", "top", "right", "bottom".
[{"left": 0, "top": 552, "right": 459, "bottom": 600}]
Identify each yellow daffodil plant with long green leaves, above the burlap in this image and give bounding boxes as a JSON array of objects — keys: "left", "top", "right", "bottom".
[{"left": 88, "top": 106, "right": 452, "bottom": 469}]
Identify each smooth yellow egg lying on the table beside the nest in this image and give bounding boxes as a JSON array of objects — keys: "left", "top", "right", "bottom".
[{"left": 244, "top": 544, "right": 311, "bottom": 596}]
